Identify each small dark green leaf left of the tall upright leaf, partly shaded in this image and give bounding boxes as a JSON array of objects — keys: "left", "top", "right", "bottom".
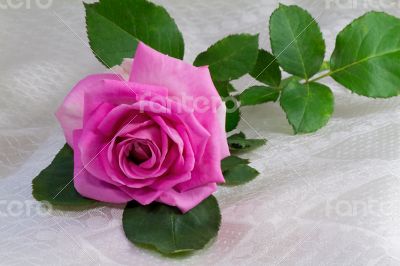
[{"left": 250, "top": 50, "right": 282, "bottom": 87}]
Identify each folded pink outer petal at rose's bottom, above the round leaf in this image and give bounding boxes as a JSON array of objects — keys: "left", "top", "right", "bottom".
[{"left": 157, "top": 183, "right": 217, "bottom": 213}]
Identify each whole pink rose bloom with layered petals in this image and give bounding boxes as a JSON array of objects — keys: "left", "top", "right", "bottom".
[{"left": 56, "top": 43, "right": 229, "bottom": 212}]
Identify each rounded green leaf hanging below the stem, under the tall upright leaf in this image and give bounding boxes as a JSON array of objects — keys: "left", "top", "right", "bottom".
[{"left": 280, "top": 82, "right": 334, "bottom": 133}]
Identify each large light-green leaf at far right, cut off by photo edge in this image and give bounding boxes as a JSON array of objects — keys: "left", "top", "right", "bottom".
[{"left": 330, "top": 12, "right": 400, "bottom": 98}]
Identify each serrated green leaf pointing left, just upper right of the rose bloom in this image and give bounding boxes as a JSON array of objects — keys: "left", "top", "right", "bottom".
[{"left": 193, "top": 34, "right": 258, "bottom": 81}]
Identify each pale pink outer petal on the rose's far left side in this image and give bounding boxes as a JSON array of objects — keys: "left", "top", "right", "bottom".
[{"left": 56, "top": 74, "right": 122, "bottom": 147}]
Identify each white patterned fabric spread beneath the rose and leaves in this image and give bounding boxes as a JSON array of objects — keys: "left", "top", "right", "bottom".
[{"left": 0, "top": 0, "right": 400, "bottom": 265}]
